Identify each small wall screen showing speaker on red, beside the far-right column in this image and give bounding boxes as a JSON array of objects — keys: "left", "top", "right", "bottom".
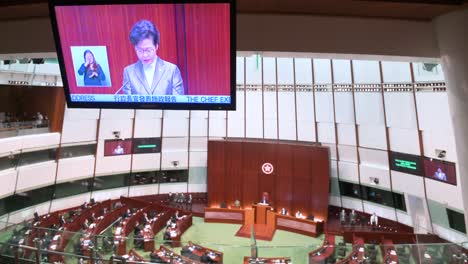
[{"left": 424, "top": 158, "right": 457, "bottom": 185}]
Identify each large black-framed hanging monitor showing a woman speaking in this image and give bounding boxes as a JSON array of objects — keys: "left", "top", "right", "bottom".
[{"left": 49, "top": 0, "right": 236, "bottom": 110}]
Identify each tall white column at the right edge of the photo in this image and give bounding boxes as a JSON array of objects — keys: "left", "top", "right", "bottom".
[{"left": 433, "top": 10, "right": 468, "bottom": 230}]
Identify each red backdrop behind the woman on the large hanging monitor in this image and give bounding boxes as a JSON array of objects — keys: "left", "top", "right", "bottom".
[{"left": 55, "top": 4, "right": 231, "bottom": 95}]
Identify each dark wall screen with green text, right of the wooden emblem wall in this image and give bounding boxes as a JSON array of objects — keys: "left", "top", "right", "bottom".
[{"left": 389, "top": 151, "right": 424, "bottom": 176}]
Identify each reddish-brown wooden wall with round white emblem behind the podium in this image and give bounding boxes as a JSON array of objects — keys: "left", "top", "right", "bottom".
[{"left": 208, "top": 139, "right": 330, "bottom": 221}]
